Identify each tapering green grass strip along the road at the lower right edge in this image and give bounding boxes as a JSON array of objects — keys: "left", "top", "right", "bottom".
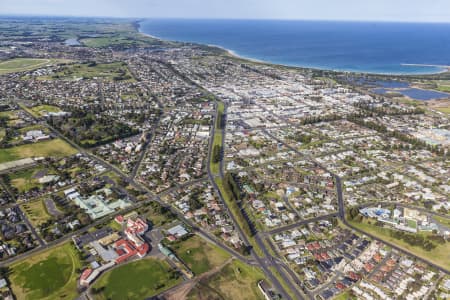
[{"left": 348, "top": 221, "right": 450, "bottom": 271}]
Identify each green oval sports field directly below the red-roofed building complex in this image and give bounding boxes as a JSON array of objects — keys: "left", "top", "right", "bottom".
[{"left": 93, "top": 258, "right": 182, "bottom": 300}]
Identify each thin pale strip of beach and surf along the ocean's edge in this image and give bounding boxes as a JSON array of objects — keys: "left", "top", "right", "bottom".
[{"left": 135, "top": 19, "right": 450, "bottom": 76}]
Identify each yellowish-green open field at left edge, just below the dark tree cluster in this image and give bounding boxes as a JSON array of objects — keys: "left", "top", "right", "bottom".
[{"left": 0, "top": 139, "right": 78, "bottom": 163}]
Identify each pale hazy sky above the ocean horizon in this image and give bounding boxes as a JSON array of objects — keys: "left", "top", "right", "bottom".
[{"left": 0, "top": 0, "right": 450, "bottom": 22}]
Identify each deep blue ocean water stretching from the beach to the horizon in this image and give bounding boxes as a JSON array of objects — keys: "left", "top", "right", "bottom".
[{"left": 140, "top": 19, "right": 450, "bottom": 74}]
